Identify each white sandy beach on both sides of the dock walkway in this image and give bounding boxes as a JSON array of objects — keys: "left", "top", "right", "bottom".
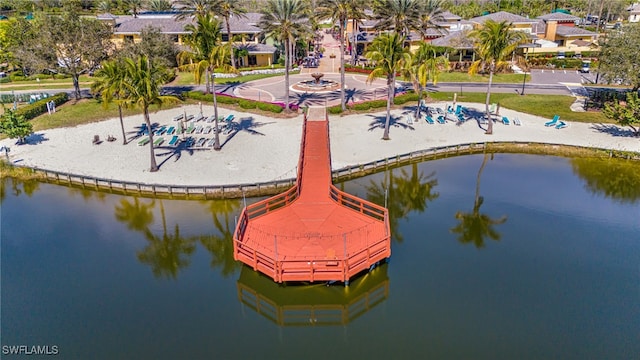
[{"left": 0, "top": 103, "right": 640, "bottom": 186}]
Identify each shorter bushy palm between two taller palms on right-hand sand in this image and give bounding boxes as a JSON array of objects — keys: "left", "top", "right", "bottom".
[{"left": 403, "top": 43, "right": 449, "bottom": 119}]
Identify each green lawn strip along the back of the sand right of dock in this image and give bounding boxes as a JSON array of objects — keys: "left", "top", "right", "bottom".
[{"left": 429, "top": 92, "right": 614, "bottom": 123}]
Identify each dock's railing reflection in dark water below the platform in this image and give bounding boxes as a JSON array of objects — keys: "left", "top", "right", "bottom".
[{"left": 237, "top": 263, "right": 389, "bottom": 326}]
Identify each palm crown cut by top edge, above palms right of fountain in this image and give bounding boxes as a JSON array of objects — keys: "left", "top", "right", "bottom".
[{"left": 373, "top": 0, "right": 422, "bottom": 38}]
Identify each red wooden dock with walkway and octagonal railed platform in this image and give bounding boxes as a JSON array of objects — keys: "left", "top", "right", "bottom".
[{"left": 233, "top": 107, "right": 391, "bottom": 283}]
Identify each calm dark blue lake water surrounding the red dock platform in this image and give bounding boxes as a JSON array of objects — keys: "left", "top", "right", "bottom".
[{"left": 0, "top": 154, "right": 640, "bottom": 359}]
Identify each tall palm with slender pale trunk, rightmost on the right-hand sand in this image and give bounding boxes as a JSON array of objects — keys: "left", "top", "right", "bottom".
[{"left": 469, "top": 20, "right": 527, "bottom": 134}]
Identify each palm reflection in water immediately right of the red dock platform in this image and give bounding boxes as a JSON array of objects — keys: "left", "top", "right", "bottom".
[{"left": 366, "top": 163, "right": 440, "bottom": 243}]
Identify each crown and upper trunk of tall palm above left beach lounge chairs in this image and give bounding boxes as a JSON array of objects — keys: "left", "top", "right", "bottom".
[{"left": 178, "top": 14, "right": 222, "bottom": 94}]
